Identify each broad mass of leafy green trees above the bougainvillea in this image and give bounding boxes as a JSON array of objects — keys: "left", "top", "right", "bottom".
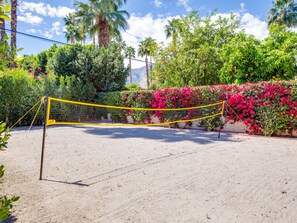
[{"left": 153, "top": 13, "right": 297, "bottom": 88}]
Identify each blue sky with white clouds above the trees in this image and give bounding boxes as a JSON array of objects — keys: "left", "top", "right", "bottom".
[{"left": 15, "top": 0, "right": 272, "bottom": 66}]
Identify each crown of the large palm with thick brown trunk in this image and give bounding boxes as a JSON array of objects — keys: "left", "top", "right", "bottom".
[{"left": 76, "top": 0, "right": 129, "bottom": 47}]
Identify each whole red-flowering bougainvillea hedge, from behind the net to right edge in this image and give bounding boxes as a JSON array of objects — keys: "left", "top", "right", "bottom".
[{"left": 99, "top": 81, "right": 297, "bottom": 136}]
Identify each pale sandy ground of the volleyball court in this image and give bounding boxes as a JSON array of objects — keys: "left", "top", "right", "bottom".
[{"left": 0, "top": 127, "right": 297, "bottom": 223}]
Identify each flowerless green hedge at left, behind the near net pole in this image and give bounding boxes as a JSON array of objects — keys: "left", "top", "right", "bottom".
[{"left": 0, "top": 69, "right": 95, "bottom": 126}]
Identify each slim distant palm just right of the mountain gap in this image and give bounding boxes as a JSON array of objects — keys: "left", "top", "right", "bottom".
[{"left": 138, "top": 37, "right": 156, "bottom": 88}]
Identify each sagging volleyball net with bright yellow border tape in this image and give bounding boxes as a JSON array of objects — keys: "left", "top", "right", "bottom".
[{"left": 45, "top": 97, "right": 225, "bottom": 126}]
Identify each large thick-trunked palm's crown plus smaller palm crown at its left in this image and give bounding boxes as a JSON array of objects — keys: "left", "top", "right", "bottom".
[{"left": 71, "top": 0, "right": 129, "bottom": 47}]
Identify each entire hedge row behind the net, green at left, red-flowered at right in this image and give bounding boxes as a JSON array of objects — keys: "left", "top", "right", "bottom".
[{"left": 0, "top": 70, "right": 297, "bottom": 136}]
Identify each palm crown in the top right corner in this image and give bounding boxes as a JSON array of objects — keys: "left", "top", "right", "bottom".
[{"left": 268, "top": 0, "right": 297, "bottom": 27}]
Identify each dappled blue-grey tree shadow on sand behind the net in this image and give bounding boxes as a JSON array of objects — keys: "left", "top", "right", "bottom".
[{"left": 84, "top": 127, "right": 233, "bottom": 145}]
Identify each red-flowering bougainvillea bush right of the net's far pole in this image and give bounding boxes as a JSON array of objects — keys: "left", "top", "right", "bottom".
[{"left": 228, "top": 82, "right": 297, "bottom": 136}]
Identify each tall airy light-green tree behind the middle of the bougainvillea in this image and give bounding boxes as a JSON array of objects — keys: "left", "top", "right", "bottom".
[{"left": 154, "top": 12, "right": 239, "bottom": 87}]
